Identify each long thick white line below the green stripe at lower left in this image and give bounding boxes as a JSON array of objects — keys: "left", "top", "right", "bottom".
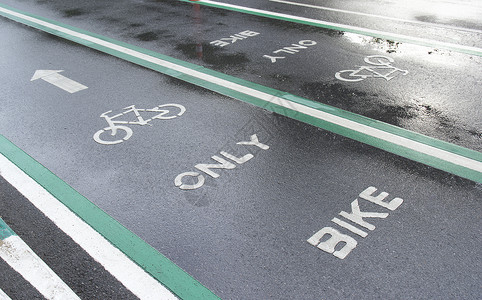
[{"left": 0, "top": 154, "right": 177, "bottom": 299}]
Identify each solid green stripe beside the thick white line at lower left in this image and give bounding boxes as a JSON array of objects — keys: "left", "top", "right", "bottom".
[{"left": 0, "top": 134, "right": 219, "bottom": 299}]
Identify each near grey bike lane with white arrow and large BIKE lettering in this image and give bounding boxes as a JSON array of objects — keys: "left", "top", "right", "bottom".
[{"left": 2, "top": 2, "right": 480, "bottom": 298}]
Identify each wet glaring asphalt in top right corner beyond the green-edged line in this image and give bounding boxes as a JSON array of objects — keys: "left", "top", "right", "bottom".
[{"left": 220, "top": 0, "right": 482, "bottom": 47}]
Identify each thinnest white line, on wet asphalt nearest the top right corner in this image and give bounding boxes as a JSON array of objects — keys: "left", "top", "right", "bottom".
[{"left": 269, "top": 0, "right": 482, "bottom": 33}]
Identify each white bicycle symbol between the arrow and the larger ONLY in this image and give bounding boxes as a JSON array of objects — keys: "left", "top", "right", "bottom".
[{"left": 94, "top": 103, "right": 186, "bottom": 145}]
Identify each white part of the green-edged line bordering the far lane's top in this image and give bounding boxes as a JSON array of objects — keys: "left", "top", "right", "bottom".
[{"left": 194, "top": 0, "right": 482, "bottom": 53}]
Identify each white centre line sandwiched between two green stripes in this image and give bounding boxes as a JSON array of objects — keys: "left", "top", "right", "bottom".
[{"left": 0, "top": 4, "right": 482, "bottom": 173}]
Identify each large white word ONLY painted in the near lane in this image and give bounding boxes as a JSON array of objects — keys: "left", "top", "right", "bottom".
[{"left": 174, "top": 134, "right": 269, "bottom": 190}]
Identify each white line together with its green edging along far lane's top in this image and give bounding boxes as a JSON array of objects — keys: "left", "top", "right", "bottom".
[{"left": 179, "top": 0, "right": 482, "bottom": 56}]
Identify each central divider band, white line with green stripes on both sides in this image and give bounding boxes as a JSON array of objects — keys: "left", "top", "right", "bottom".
[{"left": 0, "top": 1, "right": 482, "bottom": 183}]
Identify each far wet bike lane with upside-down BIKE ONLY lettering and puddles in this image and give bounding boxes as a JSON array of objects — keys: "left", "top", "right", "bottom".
[{"left": 0, "top": 1, "right": 482, "bottom": 151}]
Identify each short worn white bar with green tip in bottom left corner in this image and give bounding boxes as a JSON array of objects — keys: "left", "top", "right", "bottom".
[{"left": 0, "top": 217, "right": 80, "bottom": 300}]
